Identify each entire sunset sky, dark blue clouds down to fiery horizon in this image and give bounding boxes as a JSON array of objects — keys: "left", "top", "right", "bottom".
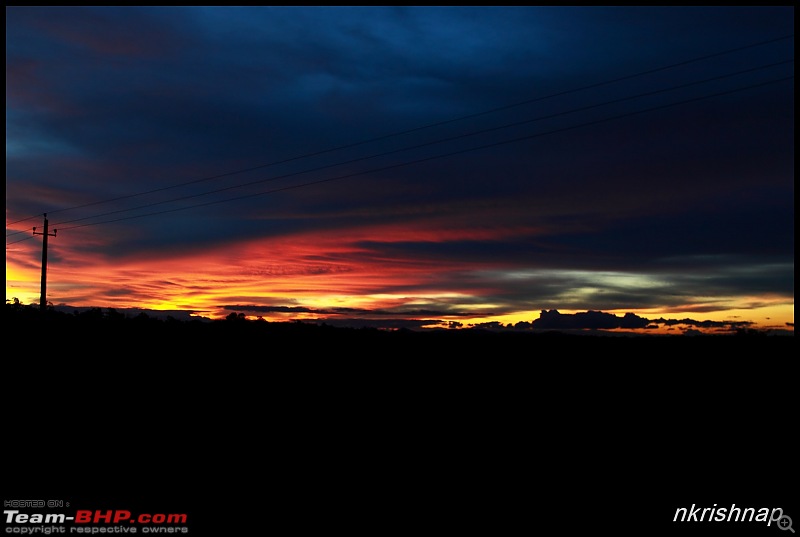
[{"left": 6, "top": 6, "right": 794, "bottom": 331}]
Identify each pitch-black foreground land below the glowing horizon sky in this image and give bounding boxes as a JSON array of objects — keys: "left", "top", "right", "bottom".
[{"left": 3, "top": 307, "right": 800, "bottom": 536}]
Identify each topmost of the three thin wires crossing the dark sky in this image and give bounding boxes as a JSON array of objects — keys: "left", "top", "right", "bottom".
[{"left": 6, "top": 33, "right": 794, "bottom": 226}]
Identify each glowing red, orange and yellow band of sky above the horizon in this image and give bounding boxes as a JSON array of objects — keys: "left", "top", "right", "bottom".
[{"left": 6, "top": 225, "right": 794, "bottom": 330}]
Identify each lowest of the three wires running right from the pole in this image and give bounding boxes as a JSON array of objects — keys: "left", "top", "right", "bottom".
[{"left": 51, "top": 75, "right": 794, "bottom": 230}]
